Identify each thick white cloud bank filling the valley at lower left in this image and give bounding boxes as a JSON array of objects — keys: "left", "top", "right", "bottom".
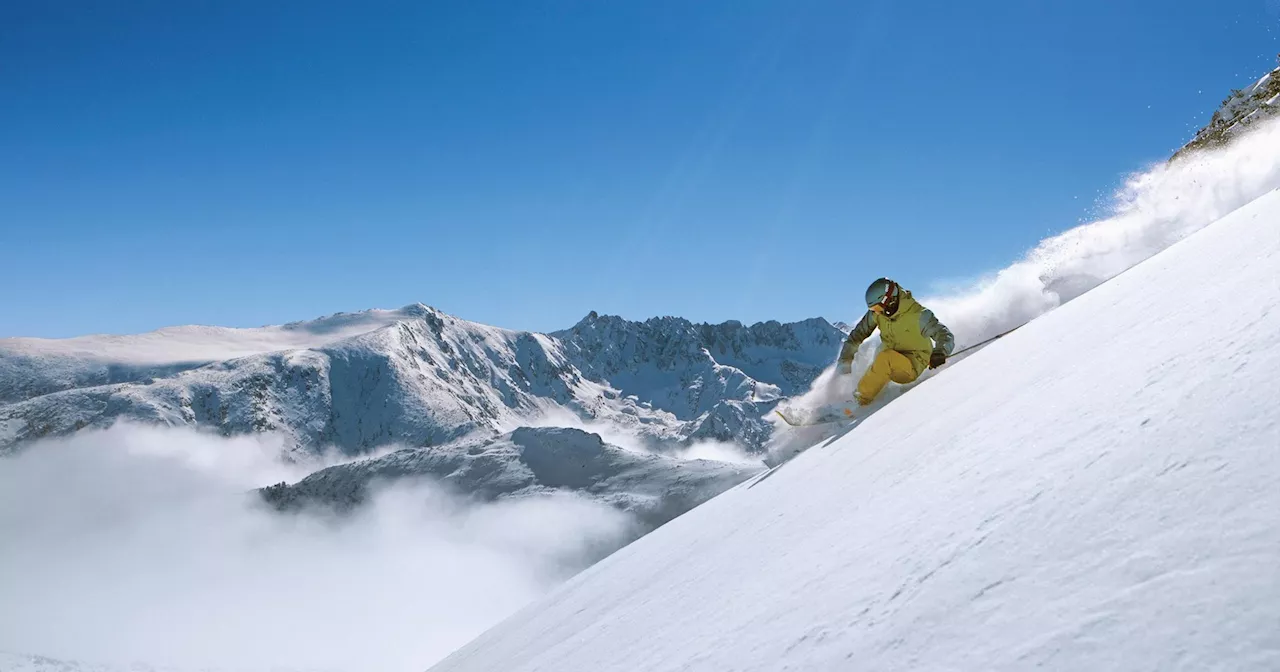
[{"left": 0, "top": 426, "right": 628, "bottom": 672}]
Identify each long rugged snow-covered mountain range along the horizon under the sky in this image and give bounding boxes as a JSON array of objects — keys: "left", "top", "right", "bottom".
[{"left": 0, "top": 305, "right": 842, "bottom": 454}]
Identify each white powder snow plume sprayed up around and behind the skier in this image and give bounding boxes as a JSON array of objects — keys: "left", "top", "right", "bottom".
[{"left": 773, "top": 119, "right": 1280, "bottom": 432}]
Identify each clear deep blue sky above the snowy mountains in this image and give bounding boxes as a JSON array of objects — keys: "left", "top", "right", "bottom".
[{"left": 0, "top": 0, "right": 1280, "bottom": 337}]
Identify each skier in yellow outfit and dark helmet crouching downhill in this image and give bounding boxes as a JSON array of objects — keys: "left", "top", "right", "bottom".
[{"left": 837, "top": 278, "right": 955, "bottom": 406}]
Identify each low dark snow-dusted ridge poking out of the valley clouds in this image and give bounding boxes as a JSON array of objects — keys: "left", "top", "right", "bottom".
[{"left": 262, "top": 428, "right": 763, "bottom": 532}]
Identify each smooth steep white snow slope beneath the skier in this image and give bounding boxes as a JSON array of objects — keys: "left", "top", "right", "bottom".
[{"left": 433, "top": 185, "right": 1280, "bottom": 672}]
